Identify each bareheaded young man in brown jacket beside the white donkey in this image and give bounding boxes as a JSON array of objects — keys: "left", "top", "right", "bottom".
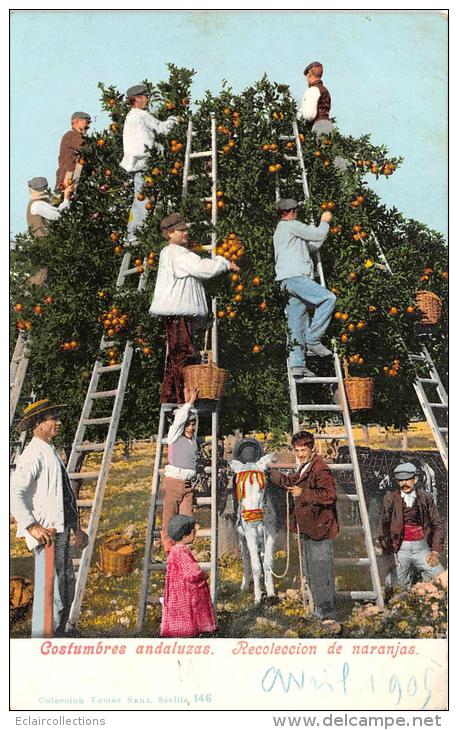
[{"left": 270, "top": 431, "right": 339, "bottom": 619}]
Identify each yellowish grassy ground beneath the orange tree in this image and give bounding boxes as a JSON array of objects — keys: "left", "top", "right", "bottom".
[{"left": 11, "top": 424, "right": 447, "bottom": 638}]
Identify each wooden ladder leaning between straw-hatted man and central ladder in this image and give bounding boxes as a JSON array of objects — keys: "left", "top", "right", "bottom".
[{"left": 67, "top": 251, "right": 148, "bottom": 628}]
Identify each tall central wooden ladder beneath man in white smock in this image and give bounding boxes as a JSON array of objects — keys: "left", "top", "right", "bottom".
[{"left": 136, "top": 114, "right": 219, "bottom": 632}]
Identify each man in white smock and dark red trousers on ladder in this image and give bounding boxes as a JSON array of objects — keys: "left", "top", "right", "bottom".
[{"left": 149, "top": 213, "right": 239, "bottom": 403}]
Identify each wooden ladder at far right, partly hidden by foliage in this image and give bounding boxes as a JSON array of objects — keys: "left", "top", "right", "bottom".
[{"left": 371, "top": 231, "right": 448, "bottom": 469}]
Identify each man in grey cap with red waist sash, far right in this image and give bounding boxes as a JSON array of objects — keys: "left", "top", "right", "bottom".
[{"left": 377, "top": 462, "right": 445, "bottom": 590}]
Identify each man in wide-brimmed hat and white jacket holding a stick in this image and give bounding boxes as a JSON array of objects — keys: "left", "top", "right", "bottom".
[{"left": 11, "top": 398, "right": 87, "bottom": 637}]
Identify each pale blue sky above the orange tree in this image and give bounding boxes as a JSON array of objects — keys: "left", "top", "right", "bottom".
[{"left": 10, "top": 10, "right": 447, "bottom": 239}]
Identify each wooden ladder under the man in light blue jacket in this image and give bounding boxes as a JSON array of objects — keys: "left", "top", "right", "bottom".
[{"left": 280, "top": 121, "right": 384, "bottom": 607}]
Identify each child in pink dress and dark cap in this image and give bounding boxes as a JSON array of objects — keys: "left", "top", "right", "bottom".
[{"left": 161, "top": 515, "right": 216, "bottom": 638}]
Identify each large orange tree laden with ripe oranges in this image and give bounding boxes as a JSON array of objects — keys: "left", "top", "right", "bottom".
[{"left": 12, "top": 65, "right": 448, "bottom": 444}]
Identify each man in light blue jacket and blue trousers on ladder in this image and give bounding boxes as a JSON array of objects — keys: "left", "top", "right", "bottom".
[{"left": 274, "top": 198, "right": 336, "bottom": 378}]
